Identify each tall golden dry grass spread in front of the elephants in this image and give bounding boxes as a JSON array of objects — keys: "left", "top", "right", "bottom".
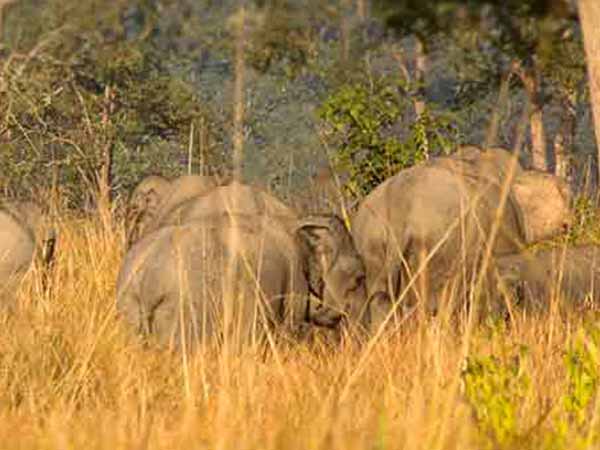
[{"left": 0, "top": 217, "right": 600, "bottom": 450}]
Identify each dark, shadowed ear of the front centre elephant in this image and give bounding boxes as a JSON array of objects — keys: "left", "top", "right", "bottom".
[{"left": 295, "top": 215, "right": 349, "bottom": 298}]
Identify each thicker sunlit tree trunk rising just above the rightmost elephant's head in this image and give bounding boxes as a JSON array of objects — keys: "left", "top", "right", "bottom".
[{"left": 516, "top": 67, "right": 548, "bottom": 171}]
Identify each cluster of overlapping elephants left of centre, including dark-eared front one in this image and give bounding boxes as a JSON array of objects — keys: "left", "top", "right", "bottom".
[{"left": 117, "top": 176, "right": 366, "bottom": 346}]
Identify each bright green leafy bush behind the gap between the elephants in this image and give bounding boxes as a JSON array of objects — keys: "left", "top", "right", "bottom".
[{"left": 319, "top": 78, "right": 458, "bottom": 196}]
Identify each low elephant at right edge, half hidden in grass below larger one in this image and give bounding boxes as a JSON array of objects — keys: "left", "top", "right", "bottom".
[{"left": 492, "top": 245, "right": 600, "bottom": 311}]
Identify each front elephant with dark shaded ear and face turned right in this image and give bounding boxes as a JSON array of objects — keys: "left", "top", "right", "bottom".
[{"left": 117, "top": 214, "right": 366, "bottom": 349}]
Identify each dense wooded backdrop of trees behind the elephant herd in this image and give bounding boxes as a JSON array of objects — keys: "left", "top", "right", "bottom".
[{"left": 0, "top": 0, "right": 597, "bottom": 206}]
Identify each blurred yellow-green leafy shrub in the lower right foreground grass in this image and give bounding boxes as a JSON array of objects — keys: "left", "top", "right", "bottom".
[{"left": 462, "top": 323, "right": 600, "bottom": 450}]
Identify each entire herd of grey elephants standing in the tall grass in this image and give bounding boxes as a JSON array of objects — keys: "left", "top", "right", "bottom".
[{"left": 0, "top": 146, "right": 597, "bottom": 349}]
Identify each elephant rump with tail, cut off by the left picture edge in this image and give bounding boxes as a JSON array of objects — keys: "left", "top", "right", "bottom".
[{"left": 0, "top": 202, "right": 56, "bottom": 297}]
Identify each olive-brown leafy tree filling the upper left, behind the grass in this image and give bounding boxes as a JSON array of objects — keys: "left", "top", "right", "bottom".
[{"left": 0, "top": 0, "right": 222, "bottom": 206}]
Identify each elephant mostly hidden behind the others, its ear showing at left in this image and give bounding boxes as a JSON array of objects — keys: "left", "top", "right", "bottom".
[{"left": 127, "top": 175, "right": 217, "bottom": 248}]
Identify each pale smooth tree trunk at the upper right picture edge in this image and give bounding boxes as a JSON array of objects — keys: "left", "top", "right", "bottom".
[{"left": 579, "top": 0, "right": 600, "bottom": 184}]
